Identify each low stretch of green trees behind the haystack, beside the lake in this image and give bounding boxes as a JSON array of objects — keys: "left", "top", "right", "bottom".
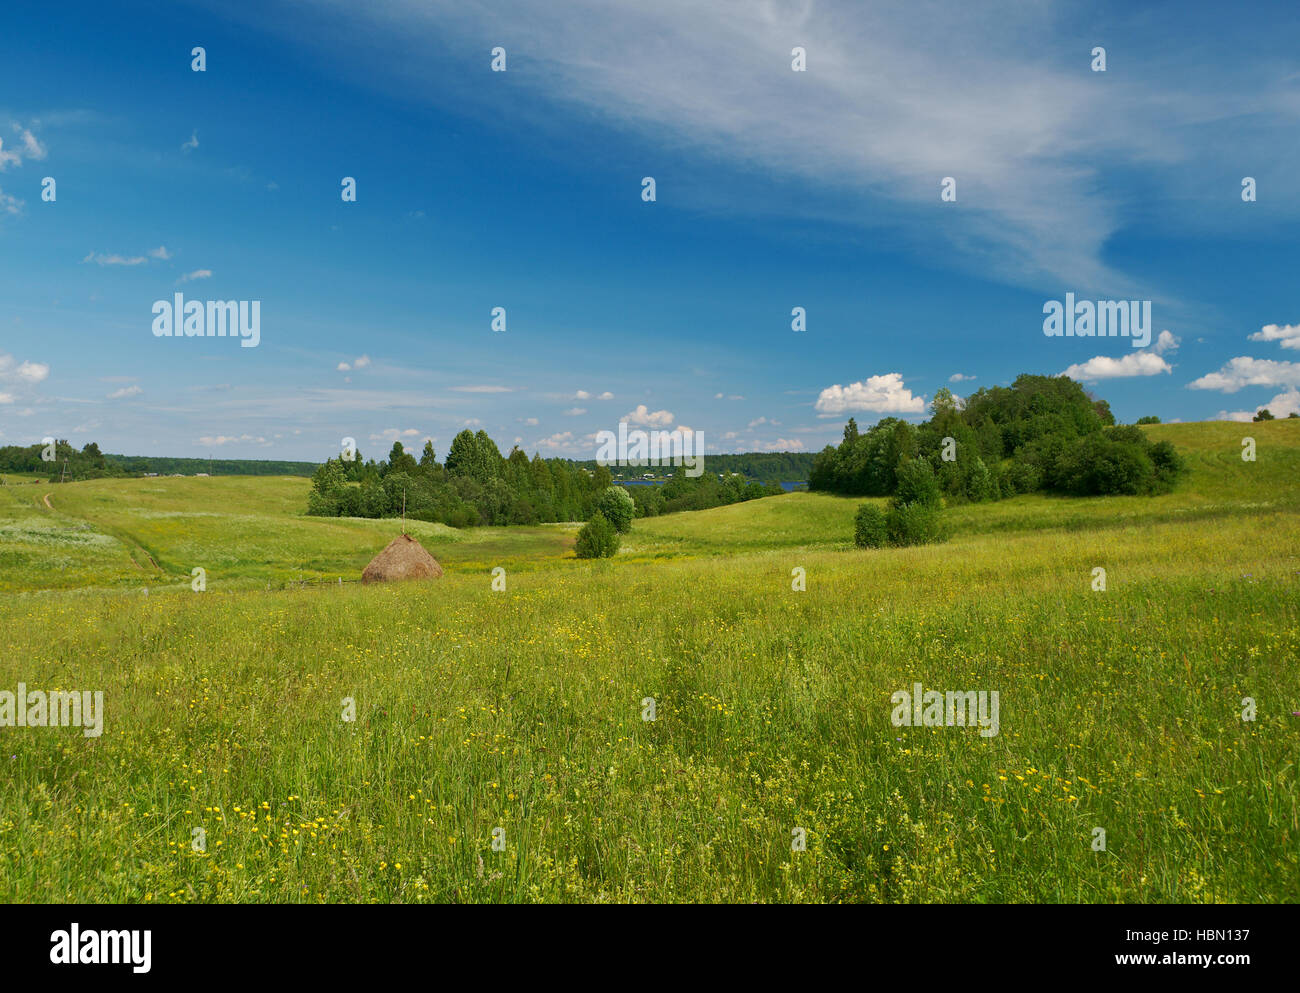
[{"left": 307, "top": 429, "right": 781, "bottom": 528}]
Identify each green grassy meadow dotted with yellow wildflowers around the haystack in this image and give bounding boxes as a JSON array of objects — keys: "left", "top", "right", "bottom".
[{"left": 0, "top": 421, "right": 1300, "bottom": 902}]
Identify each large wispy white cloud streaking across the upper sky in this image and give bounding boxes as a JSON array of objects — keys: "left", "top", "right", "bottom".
[{"left": 273, "top": 0, "right": 1296, "bottom": 286}]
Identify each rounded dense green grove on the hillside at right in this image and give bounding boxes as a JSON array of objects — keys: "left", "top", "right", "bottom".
[{"left": 809, "top": 374, "right": 1183, "bottom": 502}]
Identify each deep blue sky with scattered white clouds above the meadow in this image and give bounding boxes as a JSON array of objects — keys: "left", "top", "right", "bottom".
[{"left": 0, "top": 0, "right": 1300, "bottom": 460}]
